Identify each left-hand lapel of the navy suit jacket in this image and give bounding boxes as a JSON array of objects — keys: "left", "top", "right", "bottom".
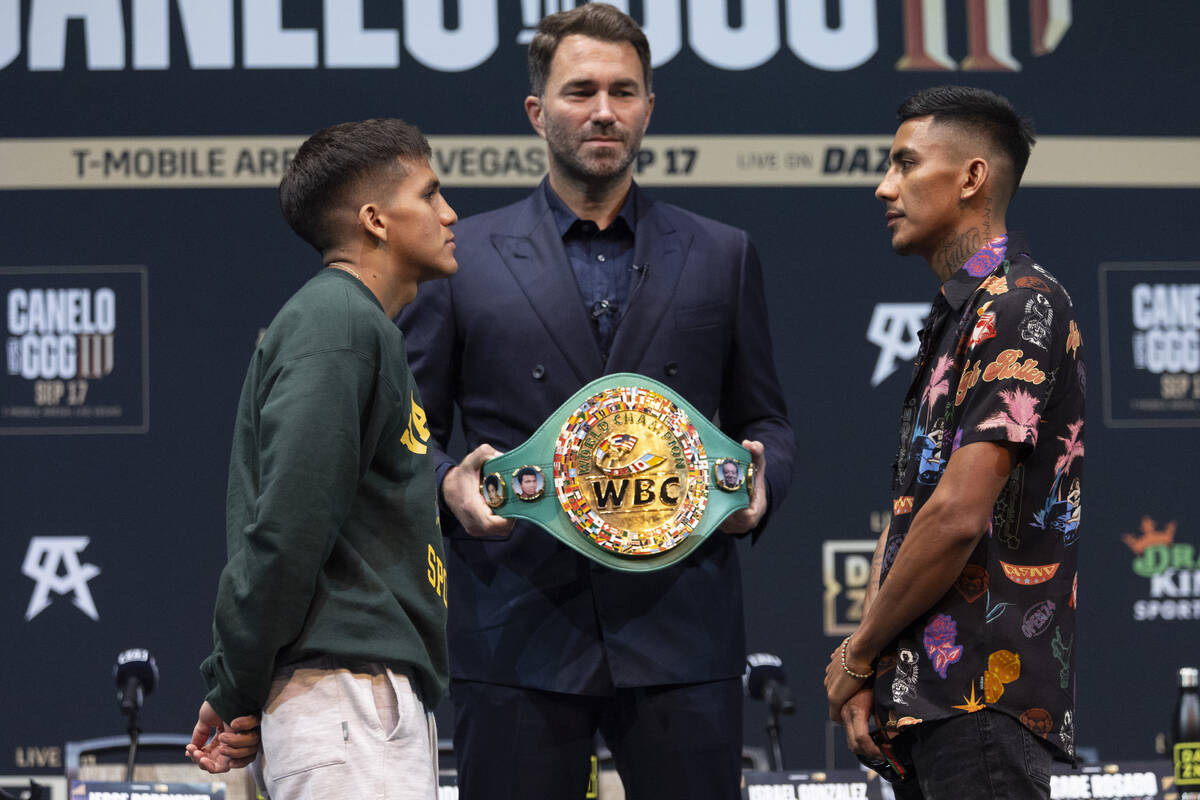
[{"left": 492, "top": 188, "right": 604, "bottom": 384}]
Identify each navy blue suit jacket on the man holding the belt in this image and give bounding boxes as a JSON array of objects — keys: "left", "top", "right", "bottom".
[{"left": 400, "top": 186, "right": 794, "bottom": 694}]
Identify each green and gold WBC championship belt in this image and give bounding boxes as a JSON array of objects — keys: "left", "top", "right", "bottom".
[{"left": 479, "top": 373, "right": 754, "bottom": 572}]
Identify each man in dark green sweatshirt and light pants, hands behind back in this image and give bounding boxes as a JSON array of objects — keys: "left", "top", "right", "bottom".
[{"left": 187, "top": 120, "right": 457, "bottom": 800}]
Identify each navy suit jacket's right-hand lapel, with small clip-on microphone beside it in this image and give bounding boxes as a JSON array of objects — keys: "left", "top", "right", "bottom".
[{"left": 608, "top": 187, "right": 691, "bottom": 377}]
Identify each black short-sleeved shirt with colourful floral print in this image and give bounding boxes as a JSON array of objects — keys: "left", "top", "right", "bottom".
[{"left": 875, "top": 234, "right": 1086, "bottom": 759}]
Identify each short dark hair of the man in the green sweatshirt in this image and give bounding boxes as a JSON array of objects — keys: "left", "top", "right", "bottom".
[{"left": 280, "top": 119, "right": 432, "bottom": 253}]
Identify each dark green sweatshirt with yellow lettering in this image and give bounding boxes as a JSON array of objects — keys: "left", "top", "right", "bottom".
[{"left": 200, "top": 269, "right": 448, "bottom": 722}]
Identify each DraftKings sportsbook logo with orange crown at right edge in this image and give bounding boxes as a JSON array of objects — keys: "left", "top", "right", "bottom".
[{"left": 1121, "top": 517, "right": 1200, "bottom": 622}]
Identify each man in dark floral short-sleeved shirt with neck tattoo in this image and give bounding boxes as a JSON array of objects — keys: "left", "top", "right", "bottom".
[{"left": 826, "top": 86, "right": 1085, "bottom": 800}]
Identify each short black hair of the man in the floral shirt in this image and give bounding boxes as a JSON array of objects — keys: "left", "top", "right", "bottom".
[{"left": 896, "top": 86, "right": 1037, "bottom": 192}]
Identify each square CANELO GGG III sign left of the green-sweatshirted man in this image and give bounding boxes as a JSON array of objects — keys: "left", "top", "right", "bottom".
[{"left": 0, "top": 267, "right": 145, "bottom": 433}]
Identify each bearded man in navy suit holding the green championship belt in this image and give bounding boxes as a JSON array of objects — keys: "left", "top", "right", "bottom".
[{"left": 401, "top": 4, "right": 794, "bottom": 800}]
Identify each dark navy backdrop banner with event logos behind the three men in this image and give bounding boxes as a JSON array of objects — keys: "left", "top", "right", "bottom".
[{"left": 0, "top": 0, "right": 1200, "bottom": 796}]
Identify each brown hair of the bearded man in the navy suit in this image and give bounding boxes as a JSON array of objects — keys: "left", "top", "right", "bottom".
[{"left": 529, "top": 2, "right": 653, "bottom": 97}]
